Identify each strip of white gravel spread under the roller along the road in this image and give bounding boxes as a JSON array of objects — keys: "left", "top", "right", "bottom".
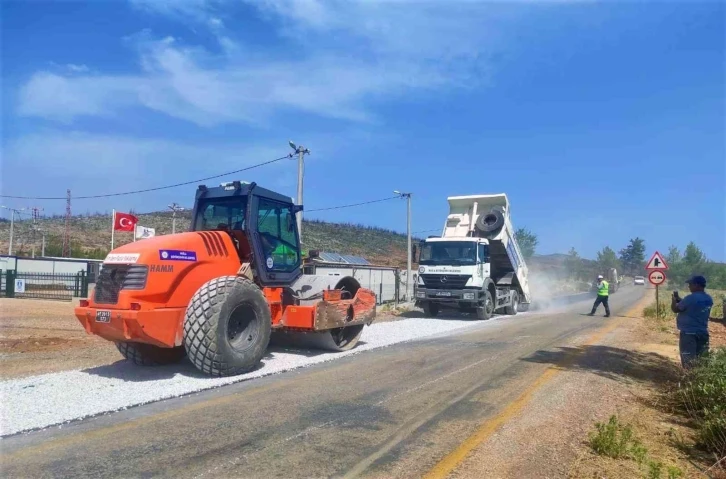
[{"left": 0, "top": 313, "right": 531, "bottom": 436}]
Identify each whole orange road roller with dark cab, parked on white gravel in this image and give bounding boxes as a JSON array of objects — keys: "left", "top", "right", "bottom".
[{"left": 75, "top": 181, "right": 376, "bottom": 376}]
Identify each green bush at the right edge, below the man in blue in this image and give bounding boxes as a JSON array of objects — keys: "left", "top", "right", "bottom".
[{"left": 677, "top": 348, "right": 726, "bottom": 457}]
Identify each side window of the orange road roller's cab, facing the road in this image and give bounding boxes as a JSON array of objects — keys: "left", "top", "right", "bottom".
[{"left": 257, "top": 198, "right": 300, "bottom": 272}]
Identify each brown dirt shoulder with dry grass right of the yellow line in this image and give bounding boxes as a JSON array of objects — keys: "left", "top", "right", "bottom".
[{"left": 451, "top": 290, "right": 726, "bottom": 479}]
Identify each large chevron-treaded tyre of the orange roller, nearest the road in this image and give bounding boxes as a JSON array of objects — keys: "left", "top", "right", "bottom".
[{"left": 184, "top": 276, "right": 272, "bottom": 376}]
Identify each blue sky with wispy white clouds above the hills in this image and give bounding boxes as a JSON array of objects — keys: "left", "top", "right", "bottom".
[{"left": 0, "top": 0, "right": 726, "bottom": 261}]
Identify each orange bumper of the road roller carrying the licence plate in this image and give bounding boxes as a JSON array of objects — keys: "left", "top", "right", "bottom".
[{"left": 75, "top": 307, "right": 185, "bottom": 348}]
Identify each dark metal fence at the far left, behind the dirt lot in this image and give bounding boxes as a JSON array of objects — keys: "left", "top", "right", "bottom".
[{"left": 2, "top": 270, "right": 88, "bottom": 301}]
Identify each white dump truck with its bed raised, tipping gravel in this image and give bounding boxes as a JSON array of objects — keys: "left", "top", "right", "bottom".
[{"left": 416, "top": 193, "right": 532, "bottom": 319}]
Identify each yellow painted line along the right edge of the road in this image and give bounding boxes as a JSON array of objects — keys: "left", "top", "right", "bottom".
[{"left": 424, "top": 296, "right": 652, "bottom": 479}]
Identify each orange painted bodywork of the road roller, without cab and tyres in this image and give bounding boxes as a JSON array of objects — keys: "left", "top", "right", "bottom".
[{"left": 75, "top": 231, "right": 376, "bottom": 347}]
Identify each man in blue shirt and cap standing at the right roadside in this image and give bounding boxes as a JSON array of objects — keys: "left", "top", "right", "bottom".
[{"left": 671, "top": 275, "right": 713, "bottom": 369}]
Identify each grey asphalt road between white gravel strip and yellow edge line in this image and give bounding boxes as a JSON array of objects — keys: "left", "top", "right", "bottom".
[{"left": 0, "top": 287, "right": 645, "bottom": 478}]
